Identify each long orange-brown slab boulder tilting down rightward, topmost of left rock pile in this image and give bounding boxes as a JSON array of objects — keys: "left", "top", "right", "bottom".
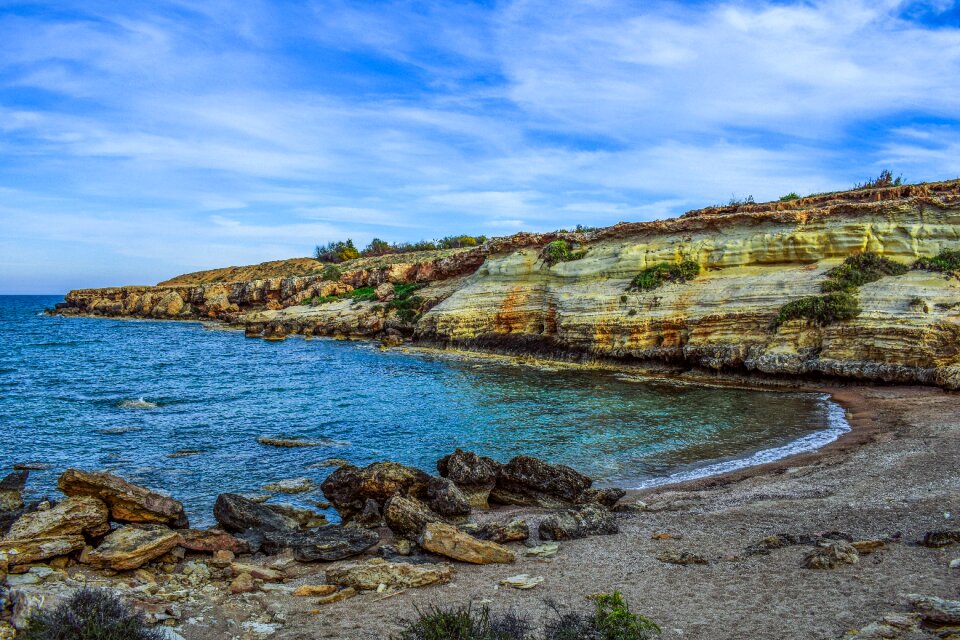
[{"left": 57, "top": 469, "right": 189, "bottom": 529}]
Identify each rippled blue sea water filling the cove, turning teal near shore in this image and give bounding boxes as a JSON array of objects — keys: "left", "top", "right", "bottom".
[{"left": 0, "top": 296, "right": 847, "bottom": 524}]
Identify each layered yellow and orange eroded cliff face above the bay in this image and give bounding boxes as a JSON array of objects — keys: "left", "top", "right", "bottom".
[{"left": 56, "top": 182, "right": 960, "bottom": 388}]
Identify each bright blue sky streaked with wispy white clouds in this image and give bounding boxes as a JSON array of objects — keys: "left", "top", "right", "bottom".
[{"left": 0, "top": 0, "right": 960, "bottom": 293}]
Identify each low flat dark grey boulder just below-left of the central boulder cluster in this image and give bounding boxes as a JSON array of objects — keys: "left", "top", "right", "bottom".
[{"left": 263, "top": 524, "right": 380, "bottom": 562}]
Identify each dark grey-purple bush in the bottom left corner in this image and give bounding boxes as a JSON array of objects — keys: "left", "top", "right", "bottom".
[{"left": 17, "top": 589, "right": 166, "bottom": 640}]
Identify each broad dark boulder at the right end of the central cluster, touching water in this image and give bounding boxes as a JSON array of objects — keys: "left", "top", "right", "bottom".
[{"left": 490, "top": 456, "right": 593, "bottom": 509}]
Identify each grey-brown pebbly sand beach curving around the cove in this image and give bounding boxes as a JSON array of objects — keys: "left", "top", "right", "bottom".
[{"left": 171, "top": 387, "right": 960, "bottom": 640}]
